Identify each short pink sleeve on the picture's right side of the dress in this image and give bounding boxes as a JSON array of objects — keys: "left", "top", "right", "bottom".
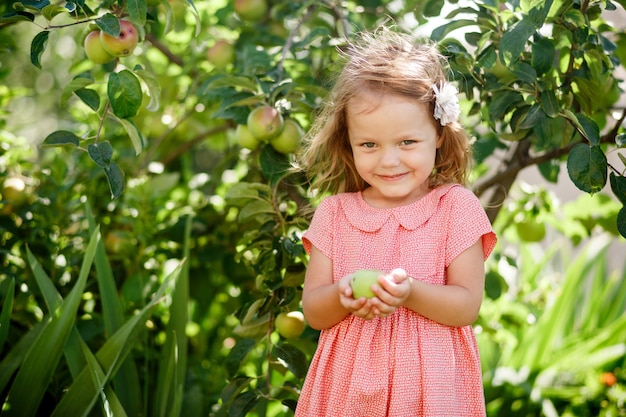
[{"left": 444, "top": 187, "right": 497, "bottom": 267}]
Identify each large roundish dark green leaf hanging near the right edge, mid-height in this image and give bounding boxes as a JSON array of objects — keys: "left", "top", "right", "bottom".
[{"left": 567, "top": 143, "right": 607, "bottom": 194}]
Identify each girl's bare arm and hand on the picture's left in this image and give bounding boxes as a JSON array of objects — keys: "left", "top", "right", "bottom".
[{"left": 302, "top": 246, "right": 375, "bottom": 330}]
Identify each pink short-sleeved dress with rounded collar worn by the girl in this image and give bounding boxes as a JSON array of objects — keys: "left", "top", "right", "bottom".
[{"left": 296, "top": 185, "right": 496, "bottom": 417}]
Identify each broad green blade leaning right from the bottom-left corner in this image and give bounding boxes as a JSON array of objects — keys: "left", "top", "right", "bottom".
[{"left": 5, "top": 228, "right": 100, "bottom": 417}]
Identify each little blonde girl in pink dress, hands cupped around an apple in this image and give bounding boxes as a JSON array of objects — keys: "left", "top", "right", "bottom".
[{"left": 296, "top": 29, "right": 496, "bottom": 417}]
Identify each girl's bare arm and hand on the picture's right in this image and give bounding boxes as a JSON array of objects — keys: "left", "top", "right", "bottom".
[{"left": 374, "top": 239, "right": 485, "bottom": 326}]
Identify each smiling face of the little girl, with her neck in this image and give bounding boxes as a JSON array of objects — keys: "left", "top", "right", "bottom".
[{"left": 347, "top": 93, "right": 440, "bottom": 208}]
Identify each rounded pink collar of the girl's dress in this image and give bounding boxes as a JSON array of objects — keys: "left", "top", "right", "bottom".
[{"left": 339, "top": 184, "right": 460, "bottom": 232}]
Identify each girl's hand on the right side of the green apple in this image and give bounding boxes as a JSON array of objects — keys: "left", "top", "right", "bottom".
[{"left": 370, "top": 268, "right": 411, "bottom": 317}]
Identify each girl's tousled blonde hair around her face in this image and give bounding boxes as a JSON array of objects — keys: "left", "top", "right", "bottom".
[{"left": 298, "top": 28, "right": 471, "bottom": 194}]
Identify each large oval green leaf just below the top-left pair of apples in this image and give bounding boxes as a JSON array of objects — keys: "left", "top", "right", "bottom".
[{"left": 107, "top": 70, "right": 143, "bottom": 119}]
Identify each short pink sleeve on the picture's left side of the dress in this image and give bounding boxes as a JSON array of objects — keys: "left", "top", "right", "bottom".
[{"left": 302, "top": 197, "right": 338, "bottom": 258}]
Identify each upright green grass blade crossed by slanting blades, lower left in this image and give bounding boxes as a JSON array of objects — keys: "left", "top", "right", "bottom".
[{"left": 85, "top": 203, "right": 142, "bottom": 415}]
